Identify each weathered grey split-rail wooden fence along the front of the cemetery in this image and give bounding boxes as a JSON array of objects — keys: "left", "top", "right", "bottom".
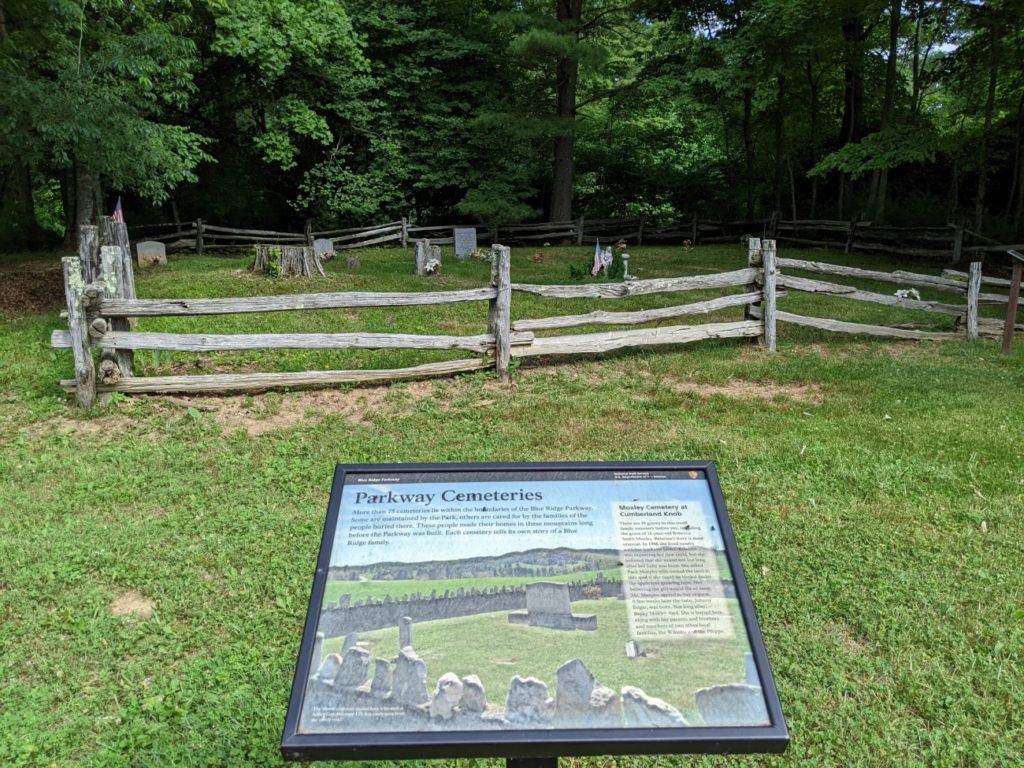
[{"left": 51, "top": 231, "right": 1008, "bottom": 408}]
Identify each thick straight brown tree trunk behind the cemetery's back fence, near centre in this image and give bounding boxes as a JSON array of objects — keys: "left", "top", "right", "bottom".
[{"left": 549, "top": 0, "right": 583, "bottom": 221}]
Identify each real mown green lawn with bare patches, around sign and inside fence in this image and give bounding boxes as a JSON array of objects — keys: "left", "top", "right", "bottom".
[{"left": 0, "top": 245, "right": 1024, "bottom": 768}]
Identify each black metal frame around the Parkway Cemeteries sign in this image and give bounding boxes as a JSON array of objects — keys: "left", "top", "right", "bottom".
[{"left": 281, "top": 461, "right": 790, "bottom": 760}]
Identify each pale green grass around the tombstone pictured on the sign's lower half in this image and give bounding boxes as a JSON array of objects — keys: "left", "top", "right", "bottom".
[{"left": 324, "top": 598, "right": 748, "bottom": 724}]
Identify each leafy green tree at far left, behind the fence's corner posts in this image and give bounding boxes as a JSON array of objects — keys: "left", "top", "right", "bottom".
[{"left": 0, "top": 0, "right": 206, "bottom": 240}]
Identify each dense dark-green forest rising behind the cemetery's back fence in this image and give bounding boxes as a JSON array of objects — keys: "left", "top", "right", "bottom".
[{"left": 0, "top": 0, "right": 1024, "bottom": 250}]
